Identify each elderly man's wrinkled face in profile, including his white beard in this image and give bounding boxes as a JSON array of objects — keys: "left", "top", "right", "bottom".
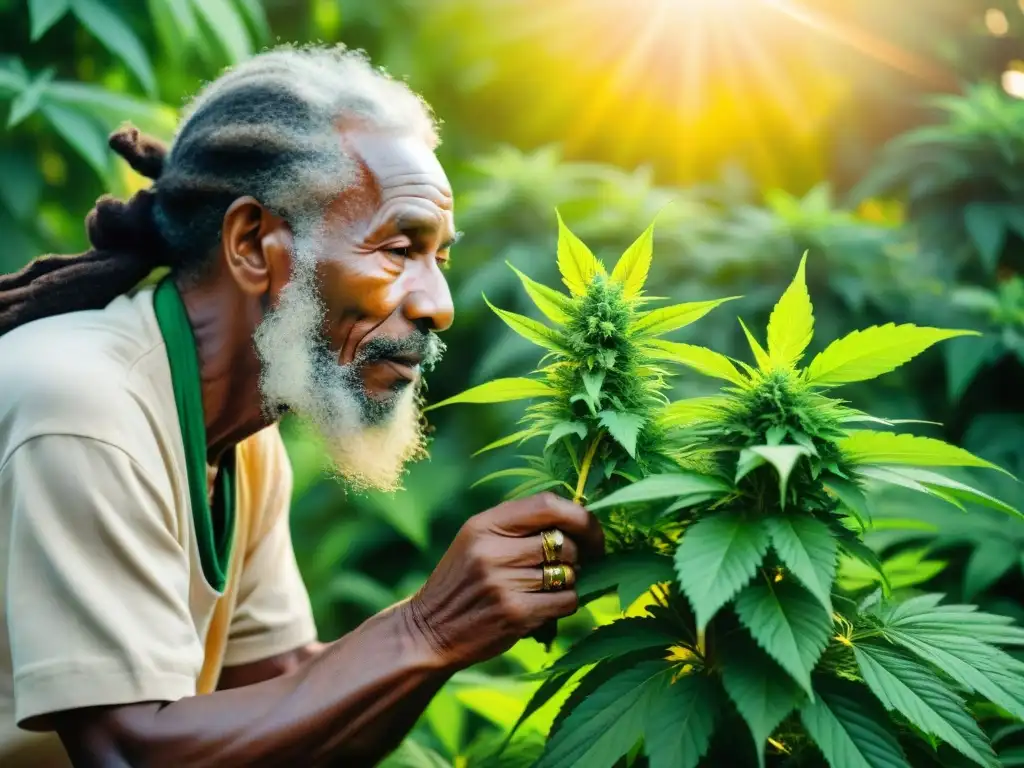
[{"left": 250, "top": 132, "right": 456, "bottom": 489}]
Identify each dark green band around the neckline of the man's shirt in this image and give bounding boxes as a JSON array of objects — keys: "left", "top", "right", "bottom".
[{"left": 153, "top": 278, "right": 236, "bottom": 592}]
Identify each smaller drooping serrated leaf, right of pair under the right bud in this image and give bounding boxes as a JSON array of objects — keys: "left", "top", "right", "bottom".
[{"left": 766, "top": 515, "right": 839, "bottom": 615}]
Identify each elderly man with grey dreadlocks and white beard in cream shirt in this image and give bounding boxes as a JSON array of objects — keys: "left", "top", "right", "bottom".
[{"left": 0, "top": 48, "right": 602, "bottom": 768}]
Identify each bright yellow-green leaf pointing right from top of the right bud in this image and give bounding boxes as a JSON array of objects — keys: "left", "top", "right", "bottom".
[{"left": 805, "top": 323, "right": 980, "bottom": 387}]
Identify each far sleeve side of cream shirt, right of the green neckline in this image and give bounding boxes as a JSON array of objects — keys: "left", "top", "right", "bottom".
[{"left": 224, "top": 427, "right": 317, "bottom": 667}]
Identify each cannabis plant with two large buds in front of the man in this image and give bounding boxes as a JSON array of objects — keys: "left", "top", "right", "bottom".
[{"left": 425, "top": 218, "right": 1024, "bottom": 768}]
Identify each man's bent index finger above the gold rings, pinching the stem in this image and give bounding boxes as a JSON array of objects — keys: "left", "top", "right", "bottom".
[{"left": 485, "top": 493, "right": 604, "bottom": 557}]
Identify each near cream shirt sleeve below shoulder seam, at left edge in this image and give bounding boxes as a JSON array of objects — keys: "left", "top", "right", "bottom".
[{"left": 0, "top": 434, "right": 203, "bottom": 730}]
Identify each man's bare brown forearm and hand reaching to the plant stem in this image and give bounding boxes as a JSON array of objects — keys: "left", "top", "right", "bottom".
[{"left": 51, "top": 494, "right": 603, "bottom": 768}]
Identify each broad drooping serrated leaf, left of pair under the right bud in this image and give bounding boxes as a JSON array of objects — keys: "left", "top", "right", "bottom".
[{"left": 675, "top": 513, "right": 768, "bottom": 632}]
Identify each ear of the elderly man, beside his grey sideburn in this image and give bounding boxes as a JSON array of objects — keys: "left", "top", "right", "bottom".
[{"left": 220, "top": 197, "right": 292, "bottom": 303}]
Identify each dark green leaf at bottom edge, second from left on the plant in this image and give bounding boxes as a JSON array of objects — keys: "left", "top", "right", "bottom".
[{"left": 644, "top": 675, "right": 722, "bottom": 768}]
